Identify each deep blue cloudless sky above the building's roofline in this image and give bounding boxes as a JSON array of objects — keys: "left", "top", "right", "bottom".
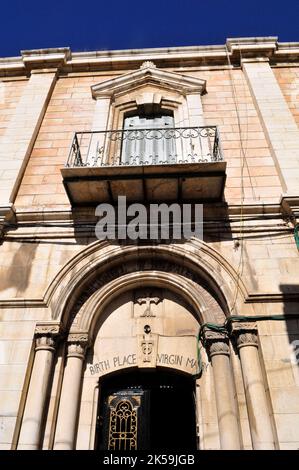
[{"left": 0, "top": 0, "right": 299, "bottom": 57}]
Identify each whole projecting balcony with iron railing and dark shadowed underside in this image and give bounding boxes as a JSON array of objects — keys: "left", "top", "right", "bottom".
[{"left": 61, "top": 126, "right": 226, "bottom": 206}]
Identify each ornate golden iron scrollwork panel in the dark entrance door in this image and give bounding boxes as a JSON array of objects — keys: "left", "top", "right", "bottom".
[{"left": 108, "top": 396, "right": 140, "bottom": 450}]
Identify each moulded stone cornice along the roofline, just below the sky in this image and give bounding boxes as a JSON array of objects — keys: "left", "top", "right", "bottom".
[{"left": 0, "top": 36, "right": 299, "bottom": 76}]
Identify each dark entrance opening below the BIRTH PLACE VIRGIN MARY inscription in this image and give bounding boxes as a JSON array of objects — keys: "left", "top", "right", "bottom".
[{"left": 95, "top": 370, "right": 196, "bottom": 450}]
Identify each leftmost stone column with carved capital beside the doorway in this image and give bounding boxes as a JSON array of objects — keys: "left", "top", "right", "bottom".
[{"left": 17, "top": 325, "right": 59, "bottom": 450}]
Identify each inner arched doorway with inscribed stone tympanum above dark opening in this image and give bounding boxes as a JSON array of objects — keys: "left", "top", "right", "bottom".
[{"left": 87, "top": 286, "right": 199, "bottom": 450}]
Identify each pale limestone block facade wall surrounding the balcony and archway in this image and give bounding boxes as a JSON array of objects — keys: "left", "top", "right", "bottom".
[{"left": 0, "top": 40, "right": 299, "bottom": 449}]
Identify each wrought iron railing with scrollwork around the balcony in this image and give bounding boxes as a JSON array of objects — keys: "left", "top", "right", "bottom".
[{"left": 66, "top": 126, "right": 223, "bottom": 168}]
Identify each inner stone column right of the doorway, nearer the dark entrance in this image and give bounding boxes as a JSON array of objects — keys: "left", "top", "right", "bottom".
[{"left": 205, "top": 331, "right": 241, "bottom": 450}]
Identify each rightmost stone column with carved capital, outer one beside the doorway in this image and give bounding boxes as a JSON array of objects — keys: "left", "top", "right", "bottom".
[{"left": 232, "top": 322, "right": 275, "bottom": 450}]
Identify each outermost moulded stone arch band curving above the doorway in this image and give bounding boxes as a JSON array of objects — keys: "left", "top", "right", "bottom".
[{"left": 45, "top": 240, "right": 251, "bottom": 326}]
